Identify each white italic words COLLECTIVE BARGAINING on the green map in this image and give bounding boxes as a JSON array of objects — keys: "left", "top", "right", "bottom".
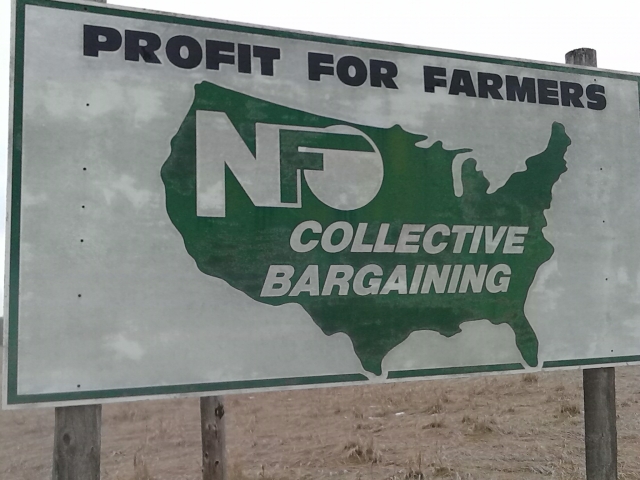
[{"left": 260, "top": 220, "right": 529, "bottom": 297}]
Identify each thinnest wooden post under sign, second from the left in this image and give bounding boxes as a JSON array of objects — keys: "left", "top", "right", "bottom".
[{"left": 200, "top": 397, "right": 227, "bottom": 480}]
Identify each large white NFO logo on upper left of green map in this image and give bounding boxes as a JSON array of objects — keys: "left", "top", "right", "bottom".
[{"left": 196, "top": 110, "right": 384, "bottom": 217}]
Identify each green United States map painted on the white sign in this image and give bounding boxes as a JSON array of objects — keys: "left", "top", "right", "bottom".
[{"left": 161, "top": 82, "right": 571, "bottom": 375}]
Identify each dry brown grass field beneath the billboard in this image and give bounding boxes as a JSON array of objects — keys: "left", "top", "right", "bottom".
[{"left": 0, "top": 358, "right": 640, "bottom": 480}]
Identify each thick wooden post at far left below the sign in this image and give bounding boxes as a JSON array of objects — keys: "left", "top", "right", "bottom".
[{"left": 52, "top": 405, "right": 102, "bottom": 480}]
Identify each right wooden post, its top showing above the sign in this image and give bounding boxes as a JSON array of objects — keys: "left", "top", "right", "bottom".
[{"left": 565, "top": 48, "right": 618, "bottom": 480}]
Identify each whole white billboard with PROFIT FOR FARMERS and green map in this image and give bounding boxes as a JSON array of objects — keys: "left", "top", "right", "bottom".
[{"left": 3, "top": 0, "right": 640, "bottom": 407}]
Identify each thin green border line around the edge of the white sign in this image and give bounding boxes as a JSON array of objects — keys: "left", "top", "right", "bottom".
[{"left": 5, "top": 0, "right": 640, "bottom": 406}]
